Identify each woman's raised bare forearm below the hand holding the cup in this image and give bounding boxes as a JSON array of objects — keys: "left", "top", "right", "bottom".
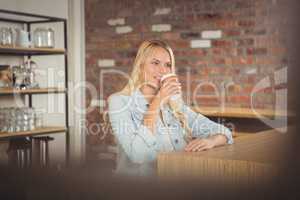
[{"left": 143, "top": 97, "right": 160, "bottom": 133}]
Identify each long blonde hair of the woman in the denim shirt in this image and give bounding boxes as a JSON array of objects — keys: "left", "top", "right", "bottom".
[{"left": 102, "top": 40, "right": 191, "bottom": 144}]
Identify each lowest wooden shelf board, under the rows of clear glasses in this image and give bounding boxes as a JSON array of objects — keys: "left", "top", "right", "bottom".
[{"left": 0, "top": 126, "right": 67, "bottom": 139}]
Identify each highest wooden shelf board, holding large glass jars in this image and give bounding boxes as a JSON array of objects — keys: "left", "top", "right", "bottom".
[{"left": 0, "top": 45, "right": 66, "bottom": 56}]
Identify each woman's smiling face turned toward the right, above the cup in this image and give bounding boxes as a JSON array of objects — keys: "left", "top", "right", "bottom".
[{"left": 144, "top": 47, "right": 172, "bottom": 88}]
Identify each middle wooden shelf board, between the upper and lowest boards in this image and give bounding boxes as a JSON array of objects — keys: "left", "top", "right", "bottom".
[{"left": 0, "top": 87, "right": 66, "bottom": 95}]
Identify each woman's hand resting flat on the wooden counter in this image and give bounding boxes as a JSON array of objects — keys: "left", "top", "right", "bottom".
[{"left": 184, "top": 134, "right": 227, "bottom": 152}]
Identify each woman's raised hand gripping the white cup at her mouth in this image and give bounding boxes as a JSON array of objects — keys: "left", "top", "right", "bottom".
[{"left": 156, "top": 76, "right": 181, "bottom": 105}]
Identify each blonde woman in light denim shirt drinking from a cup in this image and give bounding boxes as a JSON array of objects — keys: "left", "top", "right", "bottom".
[{"left": 108, "top": 40, "right": 233, "bottom": 175}]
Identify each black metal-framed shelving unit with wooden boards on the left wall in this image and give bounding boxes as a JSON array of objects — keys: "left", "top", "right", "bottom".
[{"left": 0, "top": 9, "right": 69, "bottom": 155}]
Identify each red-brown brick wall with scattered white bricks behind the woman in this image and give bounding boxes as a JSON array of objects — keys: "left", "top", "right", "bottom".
[{"left": 85, "top": 0, "right": 288, "bottom": 142}]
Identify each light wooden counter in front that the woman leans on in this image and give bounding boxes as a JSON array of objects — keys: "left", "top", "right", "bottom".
[{"left": 158, "top": 130, "right": 287, "bottom": 184}]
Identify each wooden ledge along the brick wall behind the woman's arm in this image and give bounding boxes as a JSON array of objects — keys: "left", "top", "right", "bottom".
[{"left": 193, "top": 107, "right": 293, "bottom": 118}]
